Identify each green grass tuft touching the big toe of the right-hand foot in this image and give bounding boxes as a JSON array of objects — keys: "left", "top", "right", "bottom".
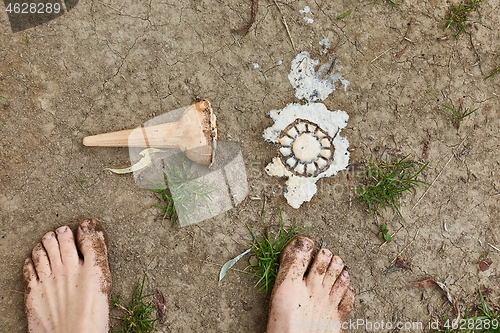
[{"left": 246, "top": 212, "right": 305, "bottom": 293}]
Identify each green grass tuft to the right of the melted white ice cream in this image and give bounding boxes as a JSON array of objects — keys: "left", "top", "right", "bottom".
[{"left": 356, "top": 155, "right": 428, "bottom": 216}]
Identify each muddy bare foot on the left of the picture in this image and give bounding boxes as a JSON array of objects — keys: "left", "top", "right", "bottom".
[{"left": 23, "top": 219, "right": 111, "bottom": 333}]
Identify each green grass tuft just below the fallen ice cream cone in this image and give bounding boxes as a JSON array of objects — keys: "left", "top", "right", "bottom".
[{"left": 151, "top": 157, "right": 218, "bottom": 227}]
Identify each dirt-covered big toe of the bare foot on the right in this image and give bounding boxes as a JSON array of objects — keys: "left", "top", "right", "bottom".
[{"left": 276, "top": 236, "right": 314, "bottom": 285}]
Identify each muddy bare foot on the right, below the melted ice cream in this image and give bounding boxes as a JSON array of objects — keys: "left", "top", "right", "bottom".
[{"left": 267, "top": 236, "right": 354, "bottom": 333}]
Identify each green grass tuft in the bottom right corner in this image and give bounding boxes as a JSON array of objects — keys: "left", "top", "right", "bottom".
[{"left": 434, "top": 287, "right": 500, "bottom": 333}]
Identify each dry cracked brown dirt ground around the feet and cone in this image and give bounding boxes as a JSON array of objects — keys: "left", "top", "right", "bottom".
[{"left": 0, "top": 0, "right": 500, "bottom": 333}]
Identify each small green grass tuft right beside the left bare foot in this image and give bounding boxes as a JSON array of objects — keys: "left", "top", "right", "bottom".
[{"left": 111, "top": 275, "right": 158, "bottom": 333}]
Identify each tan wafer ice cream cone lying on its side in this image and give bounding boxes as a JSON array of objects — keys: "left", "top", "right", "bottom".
[{"left": 83, "top": 99, "right": 217, "bottom": 165}]
